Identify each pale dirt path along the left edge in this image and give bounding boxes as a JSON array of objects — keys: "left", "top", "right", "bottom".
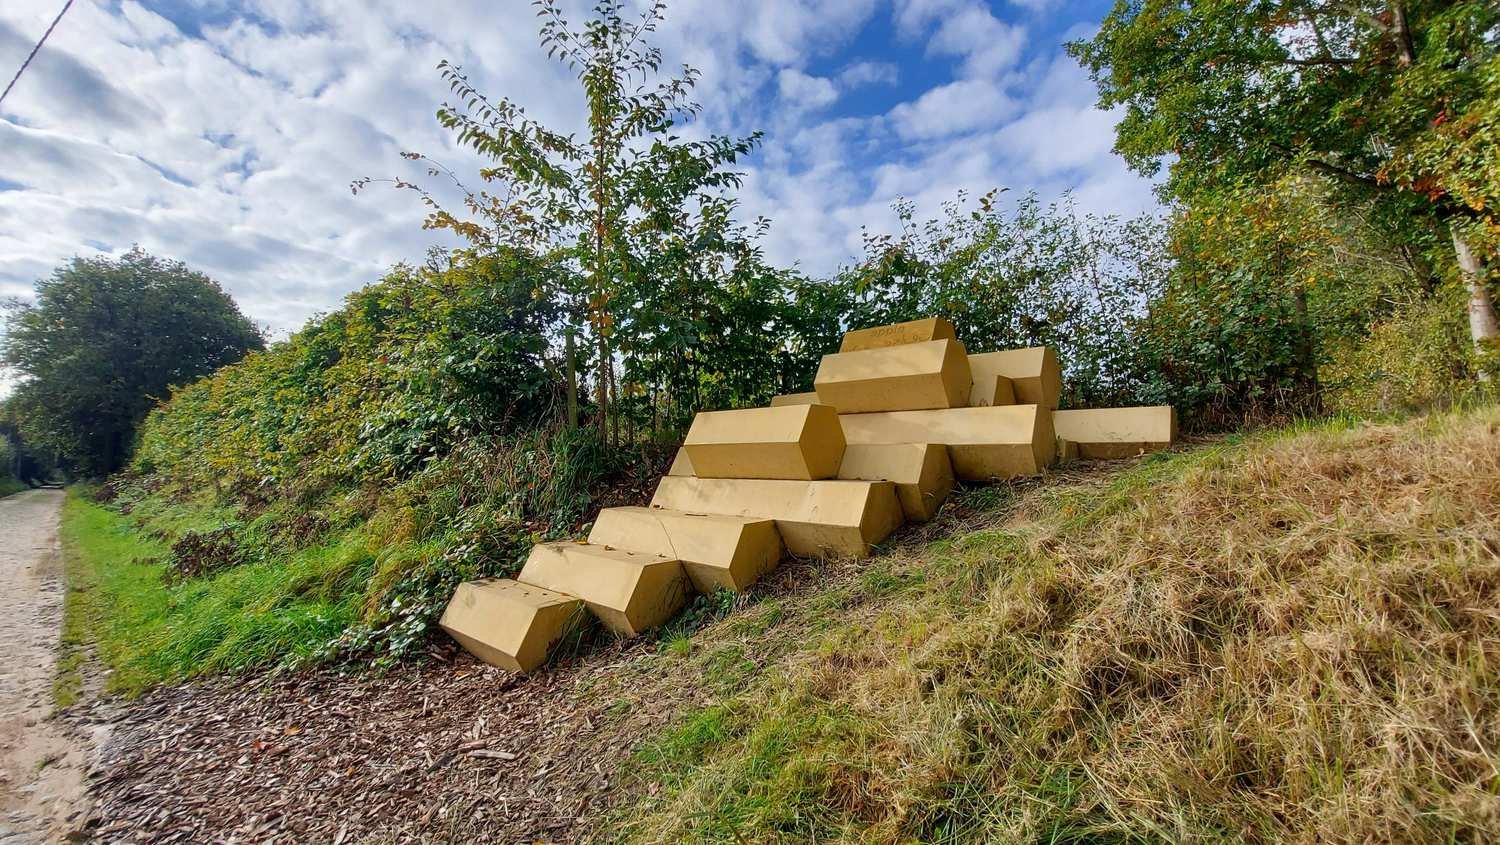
[{"left": 0, "top": 489, "right": 92, "bottom": 845}]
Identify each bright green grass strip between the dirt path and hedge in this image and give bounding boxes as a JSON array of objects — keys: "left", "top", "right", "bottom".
[{"left": 56, "top": 491, "right": 375, "bottom": 693}]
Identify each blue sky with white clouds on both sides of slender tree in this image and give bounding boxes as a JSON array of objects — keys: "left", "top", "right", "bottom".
[{"left": 0, "top": 0, "right": 1154, "bottom": 336}]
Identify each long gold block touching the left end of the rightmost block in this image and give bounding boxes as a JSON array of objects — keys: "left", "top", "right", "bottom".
[{"left": 839, "top": 405, "right": 1058, "bottom": 480}]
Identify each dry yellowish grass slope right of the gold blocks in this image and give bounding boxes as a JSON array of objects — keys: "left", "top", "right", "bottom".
[{"left": 597, "top": 408, "right": 1500, "bottom": 842}]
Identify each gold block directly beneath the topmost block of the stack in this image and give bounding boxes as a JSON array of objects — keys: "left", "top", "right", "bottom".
[{"left": 813, "top": 341, "right": 972, "bottom": 414}]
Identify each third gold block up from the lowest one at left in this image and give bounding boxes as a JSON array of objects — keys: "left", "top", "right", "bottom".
[{"left": 588, "top": 507, "right": 782, "bottom": 593}]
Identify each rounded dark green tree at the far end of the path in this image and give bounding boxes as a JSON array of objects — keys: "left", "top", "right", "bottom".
[{"left": 0, "top": 248, "right": 264, "bottom": 474}]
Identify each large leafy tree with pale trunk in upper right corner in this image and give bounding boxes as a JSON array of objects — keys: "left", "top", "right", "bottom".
[{"left": 1070, "top": 0, "right": 1500, "bottom": 369}]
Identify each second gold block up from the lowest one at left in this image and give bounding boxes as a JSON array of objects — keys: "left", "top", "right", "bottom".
[{"left": 516, "top": 542, "right": 689, "bottom": 636}]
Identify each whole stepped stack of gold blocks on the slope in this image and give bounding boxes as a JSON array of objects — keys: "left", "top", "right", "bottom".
[{"left": 441, "top": 318, "right": 1178, "bottom": 672}]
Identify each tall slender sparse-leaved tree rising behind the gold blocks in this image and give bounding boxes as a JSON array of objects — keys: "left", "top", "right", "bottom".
[{"left": 356, "top": 0, "right": 759, "bottom": 447}]
